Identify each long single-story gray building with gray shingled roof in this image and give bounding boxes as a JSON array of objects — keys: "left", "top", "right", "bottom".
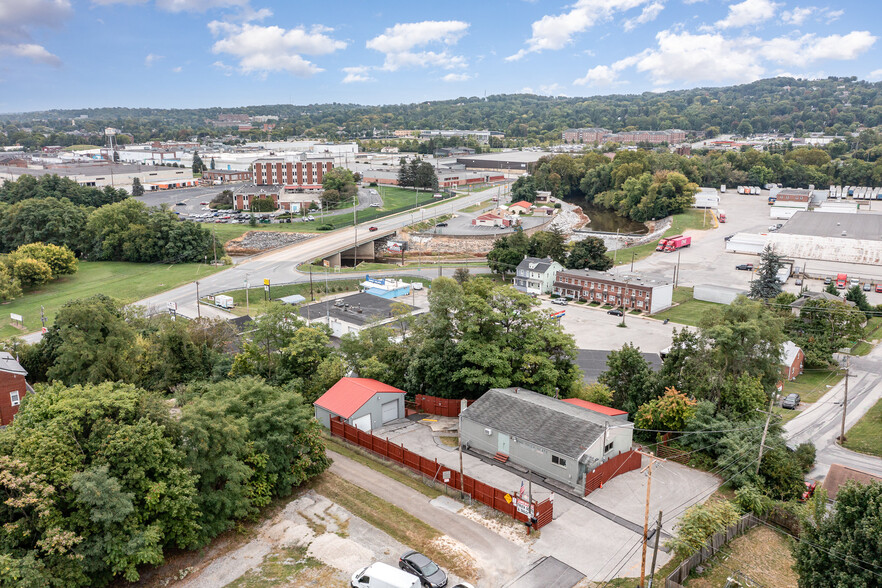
[{"left": 459, "top": 388, "right": 634, "bottom": 489}]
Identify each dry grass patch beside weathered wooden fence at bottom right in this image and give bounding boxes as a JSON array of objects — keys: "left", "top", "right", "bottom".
[{"left": 685, "top": 525, "right": 798, "bottom": 588}]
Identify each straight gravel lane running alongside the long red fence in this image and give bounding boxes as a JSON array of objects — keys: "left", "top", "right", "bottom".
[{"left": 328, "top": 451, "right": 529, "bottom": 586}]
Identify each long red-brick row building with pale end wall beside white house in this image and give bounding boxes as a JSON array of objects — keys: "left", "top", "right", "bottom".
[{"left": 554, "top": 270, "right": 674, "bottom": 314}]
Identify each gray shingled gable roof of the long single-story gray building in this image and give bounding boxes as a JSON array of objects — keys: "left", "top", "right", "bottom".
[{"left": 462, "top": 388, "right": 622, "bottom": 459}]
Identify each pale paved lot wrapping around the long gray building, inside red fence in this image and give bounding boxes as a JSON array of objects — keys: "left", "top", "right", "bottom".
[{"left": 373, "top": 416, "right": 719, "bottom": 581}]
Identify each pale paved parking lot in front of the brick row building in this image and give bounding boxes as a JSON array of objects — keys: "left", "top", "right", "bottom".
[{"left": 541, "top": 299, "right": 692, "bottom": 353}]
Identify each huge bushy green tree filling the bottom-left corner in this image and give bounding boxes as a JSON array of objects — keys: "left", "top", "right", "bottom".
[{"left": 0, "top": 383, "right": 199, "bottom": 586}]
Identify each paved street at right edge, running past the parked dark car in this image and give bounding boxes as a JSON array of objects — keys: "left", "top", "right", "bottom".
[{"left": 784, "top": 346, "right": 882, "bottom": 480}]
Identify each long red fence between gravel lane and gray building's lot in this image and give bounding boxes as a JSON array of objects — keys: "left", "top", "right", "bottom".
[{"left": 331, "top": 419, "right": 554, "bottom": 529}]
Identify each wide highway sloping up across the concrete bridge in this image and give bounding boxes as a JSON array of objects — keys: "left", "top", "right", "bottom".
[{"left": 137, "top": 188, "right": 500, "bottom": 317}]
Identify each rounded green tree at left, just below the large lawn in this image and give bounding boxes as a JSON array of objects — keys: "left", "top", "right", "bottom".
[{"left": 41, "top": 294, "right": 137, "bottom": 384}]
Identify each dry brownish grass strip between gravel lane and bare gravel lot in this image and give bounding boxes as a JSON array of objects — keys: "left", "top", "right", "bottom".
[{"left": 310, "top": 472, "right": 476, "bottom": 581}]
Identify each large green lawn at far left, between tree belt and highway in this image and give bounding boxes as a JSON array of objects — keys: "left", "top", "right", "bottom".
[{"left": 0, "top": 261, "right": 224, "bottom": 338}]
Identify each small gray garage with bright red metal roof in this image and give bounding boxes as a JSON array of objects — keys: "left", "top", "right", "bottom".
[{"left": 313, "top": 378, "right": 404, "bottom": 431}]
